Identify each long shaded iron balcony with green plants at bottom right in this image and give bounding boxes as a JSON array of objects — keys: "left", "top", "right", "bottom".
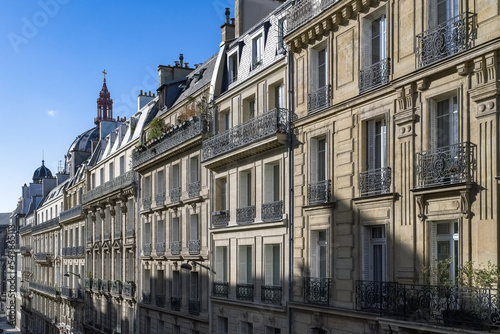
[{"left": 356, "top": 281, "right": 500, "bottom": 330}]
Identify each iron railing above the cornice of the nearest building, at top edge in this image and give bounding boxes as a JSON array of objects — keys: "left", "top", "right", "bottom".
[{"left": 286, "top": 0, "right": 339, "bottom": 33}]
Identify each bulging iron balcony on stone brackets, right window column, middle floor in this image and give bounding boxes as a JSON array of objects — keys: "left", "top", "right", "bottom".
[{"left": 417, "top": 142, "right": 476, "bottom": 188}]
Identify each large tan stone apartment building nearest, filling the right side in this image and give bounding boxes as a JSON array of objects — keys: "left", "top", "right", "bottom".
[{"left": 285, "top": 0, "right": 500, "bottom": 333}]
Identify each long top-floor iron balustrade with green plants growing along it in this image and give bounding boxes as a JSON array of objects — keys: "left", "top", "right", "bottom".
[{"left": 132, "top": 115, "right": 208, "bottom": 168}]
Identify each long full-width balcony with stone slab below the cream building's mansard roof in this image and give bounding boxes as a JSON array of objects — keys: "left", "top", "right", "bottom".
[{"left": 202, "top": 108, "right": 288, "bottom": 168}]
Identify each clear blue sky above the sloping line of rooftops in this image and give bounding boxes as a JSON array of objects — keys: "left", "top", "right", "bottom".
[{"left": 0, "top": 0, "right": 234, "bottom": 212}]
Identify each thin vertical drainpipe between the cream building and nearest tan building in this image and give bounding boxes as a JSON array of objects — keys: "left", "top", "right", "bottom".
[{"left": 288, "top": 51, "right": 294, "bottom": 334}]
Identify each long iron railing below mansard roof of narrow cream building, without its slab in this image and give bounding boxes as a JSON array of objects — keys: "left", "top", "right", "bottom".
[{"left": 202, "top": 108, "right": 288, "bottom": 161}]
